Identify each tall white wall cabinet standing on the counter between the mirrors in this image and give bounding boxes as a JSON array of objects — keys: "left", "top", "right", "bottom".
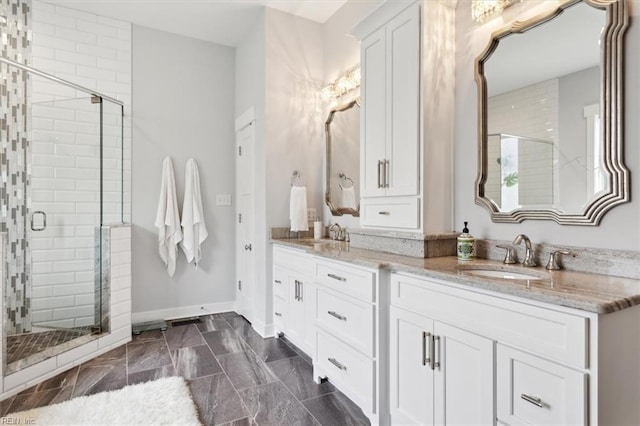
[{"left": 354, "top": 1, "right": 454, "bottom": 232}]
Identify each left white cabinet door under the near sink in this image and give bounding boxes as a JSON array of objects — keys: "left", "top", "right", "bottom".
[{"left": 390, "top": 306, "right": 433, "bottom": 425}]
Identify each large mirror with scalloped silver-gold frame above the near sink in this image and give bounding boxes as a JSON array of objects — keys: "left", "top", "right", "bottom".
[{"left": 475, "top": 0, "right": 630, "bottom": 225}]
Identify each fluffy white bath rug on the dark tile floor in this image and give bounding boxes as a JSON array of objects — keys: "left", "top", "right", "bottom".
[{"left": 3, "top": 377, "right": 200, "bottom": 426}]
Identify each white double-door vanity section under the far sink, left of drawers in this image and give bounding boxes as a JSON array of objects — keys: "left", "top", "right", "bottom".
[{"left": 273, "top": 246, "right": 316, "bottom": 355}]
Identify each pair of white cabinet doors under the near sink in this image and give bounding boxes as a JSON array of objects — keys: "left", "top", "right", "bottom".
[{"left": 390, "top": 288, "right": 495, "bottom": 425}]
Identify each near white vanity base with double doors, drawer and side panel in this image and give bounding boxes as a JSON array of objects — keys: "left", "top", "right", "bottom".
[{"left": 390, "top": 273, "right": 640, "bottom": 425}]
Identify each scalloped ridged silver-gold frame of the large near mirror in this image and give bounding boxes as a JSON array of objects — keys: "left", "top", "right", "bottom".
[{"left": 475, "top": 0, "right": 630, "bottom": 226}]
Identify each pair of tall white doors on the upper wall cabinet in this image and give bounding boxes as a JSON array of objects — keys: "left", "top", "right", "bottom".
[{"left": 361, "top": 3, "right": 421, "bottom": 197}]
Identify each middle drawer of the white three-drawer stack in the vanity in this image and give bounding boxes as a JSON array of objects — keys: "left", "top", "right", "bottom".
[{"left": 316, "top": 289, "right": 375, "bottom": 357}]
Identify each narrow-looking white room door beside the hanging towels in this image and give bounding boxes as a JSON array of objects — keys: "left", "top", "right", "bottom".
[{"left": 236, "top": 121, "right": 256, "bottom": 321}]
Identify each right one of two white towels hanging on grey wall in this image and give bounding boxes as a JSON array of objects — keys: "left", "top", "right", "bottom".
[{"left": 181, "top": 158, "right": 209, "bottom": 266}]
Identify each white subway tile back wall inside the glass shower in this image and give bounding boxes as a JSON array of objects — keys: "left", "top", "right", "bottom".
[{"left": 30, "top": 1, "right": 131, "bottom": 327}]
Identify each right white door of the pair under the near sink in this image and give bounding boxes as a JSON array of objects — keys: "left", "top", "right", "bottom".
[{"left": 434, "top": 321, "right": 496, "bottom": 425}]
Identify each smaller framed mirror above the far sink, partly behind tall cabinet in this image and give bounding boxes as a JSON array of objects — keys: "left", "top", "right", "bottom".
[{"left": 324, "top": 98, "right": 360, "bottom": 217}]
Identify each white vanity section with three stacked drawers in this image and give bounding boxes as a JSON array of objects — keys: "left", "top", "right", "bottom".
[{"left": 313, "top": 259, "right": 388, "bottom": 424}]
